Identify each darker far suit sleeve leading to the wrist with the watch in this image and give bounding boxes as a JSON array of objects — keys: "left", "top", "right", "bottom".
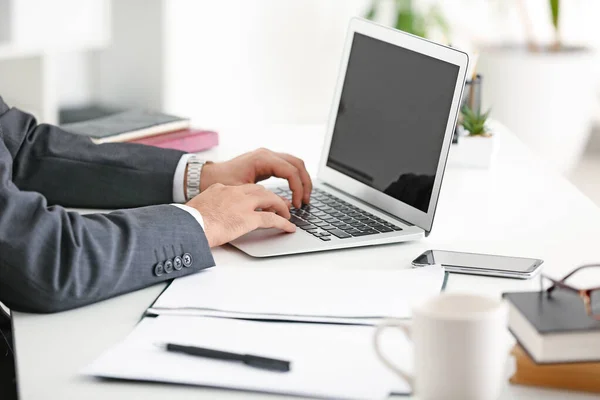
[{"left": 0, "top": 98, "right": 184, "bottom": 208}]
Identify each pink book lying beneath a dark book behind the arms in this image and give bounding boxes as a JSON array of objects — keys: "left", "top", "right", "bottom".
[{"left": 130, "top": 129, "right": 219, "bottom": 153}]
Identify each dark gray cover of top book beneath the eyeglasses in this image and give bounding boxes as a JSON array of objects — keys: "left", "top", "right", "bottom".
[{"left": 503, "top": 289, "right": 600, "bottom": 335}]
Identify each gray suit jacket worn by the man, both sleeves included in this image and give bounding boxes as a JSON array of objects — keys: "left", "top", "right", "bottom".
[{"left": 0, "top": 97, "right": 214, "bottom": 312}]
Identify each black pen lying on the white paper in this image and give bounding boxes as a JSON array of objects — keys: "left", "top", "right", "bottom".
[{"left": 156, "top": 343, "right": 290, "bottom": 372}]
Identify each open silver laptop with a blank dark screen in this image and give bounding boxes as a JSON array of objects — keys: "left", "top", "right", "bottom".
[{"left": 231, "top": 19, "right": 468, "bottom": 257}]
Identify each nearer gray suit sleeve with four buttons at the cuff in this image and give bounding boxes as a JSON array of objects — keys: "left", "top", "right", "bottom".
[{"left": 0, "top": 97, "right": 214, "bottom": 312}]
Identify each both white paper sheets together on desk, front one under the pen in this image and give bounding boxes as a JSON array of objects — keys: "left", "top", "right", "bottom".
[{"left": 84, "top": 266, "right": 445, "bottom": 399}]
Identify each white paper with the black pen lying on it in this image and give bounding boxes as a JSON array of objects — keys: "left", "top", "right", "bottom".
[{"left": 83, "top": 316, "right": 412, "bottom": 399}]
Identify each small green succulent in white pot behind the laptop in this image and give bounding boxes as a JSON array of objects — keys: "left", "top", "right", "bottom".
[{"left": 448, "top": 105, "right": 495, "bottom": 168}]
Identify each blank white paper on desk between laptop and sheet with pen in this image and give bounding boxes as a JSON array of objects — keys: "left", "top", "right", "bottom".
[{"left": 152, "top": 266, "right": 444, "bottom": 319}]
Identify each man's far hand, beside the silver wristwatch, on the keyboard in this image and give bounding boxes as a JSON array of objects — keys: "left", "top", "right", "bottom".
[{"left": 200, "top": 149, "right": 312, "bottom": 208}]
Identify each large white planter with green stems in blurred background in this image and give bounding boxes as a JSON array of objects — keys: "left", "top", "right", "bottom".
[{"left": 478, "top": 0, "right": 597, "bottom": 172}]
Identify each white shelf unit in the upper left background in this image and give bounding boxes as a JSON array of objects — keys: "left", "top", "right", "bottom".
[{"left": 0, "top": 0, "right": 109, "bottom": 123}]
